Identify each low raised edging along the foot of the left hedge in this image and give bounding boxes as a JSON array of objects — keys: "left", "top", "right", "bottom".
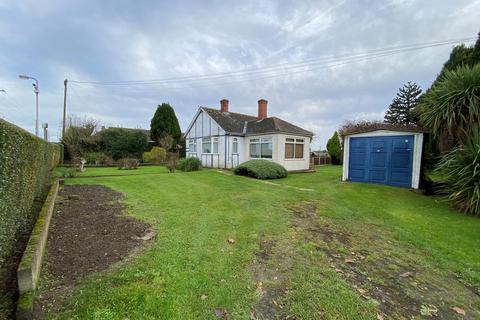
[{"left": 17, "top": 179, "right": 60, "bottom": 319}]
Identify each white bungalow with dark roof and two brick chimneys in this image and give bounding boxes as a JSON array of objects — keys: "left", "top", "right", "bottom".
[{"left": 185, "top": 99, "right": 313, "bottom": 171}]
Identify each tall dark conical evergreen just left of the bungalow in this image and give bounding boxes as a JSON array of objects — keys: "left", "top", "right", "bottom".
[{"left": 150, "top": 103, "right": 182, "bottom": 146}]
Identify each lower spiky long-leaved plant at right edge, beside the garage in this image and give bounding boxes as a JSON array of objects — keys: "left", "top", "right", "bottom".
[{"left": 437, "top": 126, "right": 480, "bottom": 215}]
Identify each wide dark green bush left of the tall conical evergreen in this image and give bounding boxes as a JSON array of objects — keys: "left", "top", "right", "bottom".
[{"left": 101, "top": 128, "right": 148, "bottom": 160}]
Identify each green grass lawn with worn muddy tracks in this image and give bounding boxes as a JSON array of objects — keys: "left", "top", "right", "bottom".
[{"left": 43, "top": 166, "right": 480, "bottom": 319}]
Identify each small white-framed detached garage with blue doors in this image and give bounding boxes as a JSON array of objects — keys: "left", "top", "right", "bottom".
[{"left": 343, "top": 130, "right": 423, "bottom": 189}]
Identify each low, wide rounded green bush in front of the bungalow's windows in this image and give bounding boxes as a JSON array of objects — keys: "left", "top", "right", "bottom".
[{"left": 234, "top": 160, "right": 287, "bottom": 179}]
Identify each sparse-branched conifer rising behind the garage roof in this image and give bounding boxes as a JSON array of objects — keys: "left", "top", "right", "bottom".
[{"left": 385, "top": 81, "right": 422, "bottom": 124}]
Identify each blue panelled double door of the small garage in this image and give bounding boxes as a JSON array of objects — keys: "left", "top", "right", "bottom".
[{"left": 348, "top": 136, "right": 413, "bottom": 188}]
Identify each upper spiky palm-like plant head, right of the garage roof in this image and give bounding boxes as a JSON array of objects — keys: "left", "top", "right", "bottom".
[{"left": 416, "top": 64, "right": 480, "bottom": 150}]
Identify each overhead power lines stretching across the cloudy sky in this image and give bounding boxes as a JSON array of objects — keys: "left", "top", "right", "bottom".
[{"left": 70, "top": 38, "right": 476, "bottom": 86}]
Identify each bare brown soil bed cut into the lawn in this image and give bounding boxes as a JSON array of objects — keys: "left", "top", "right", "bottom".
[{"left": 35, "top": 185, "right": 149, "bottom": 318}]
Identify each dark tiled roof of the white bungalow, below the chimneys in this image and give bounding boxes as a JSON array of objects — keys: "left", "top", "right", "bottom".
[{"left": 201, "top": 107, "right": 313, "bottom": 136}]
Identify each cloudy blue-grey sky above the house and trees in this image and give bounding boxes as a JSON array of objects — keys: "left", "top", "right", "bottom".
[{"left": 0, "top": 0, "right": 480, "bottom": 149}]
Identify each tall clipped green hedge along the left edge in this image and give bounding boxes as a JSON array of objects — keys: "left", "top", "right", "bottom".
[{"left": 0, "top": 119, "right": 60, "bottom": 314}]
